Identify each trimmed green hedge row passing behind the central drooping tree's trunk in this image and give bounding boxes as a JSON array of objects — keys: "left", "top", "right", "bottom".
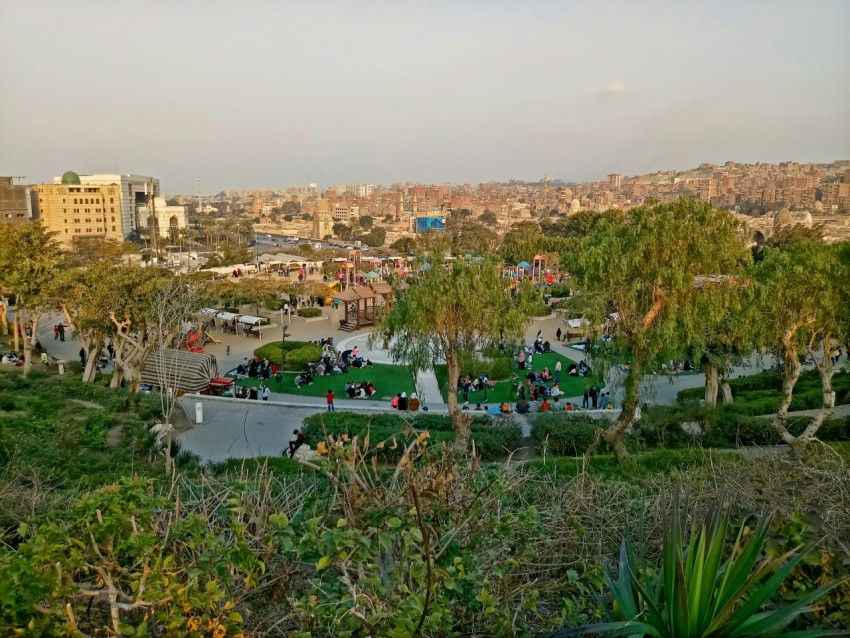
[{"left": 304, "top": 412, "right": 523, "bottom": 461}]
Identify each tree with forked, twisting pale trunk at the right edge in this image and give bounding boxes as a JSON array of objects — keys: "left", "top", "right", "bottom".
[{"left": 754, "top": 237, "right": 850, "bottom": 456}]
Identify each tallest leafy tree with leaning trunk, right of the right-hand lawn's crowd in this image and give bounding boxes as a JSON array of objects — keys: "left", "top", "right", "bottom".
[{"left": 572, "top": 199, "right": 750, "bottom": 460}]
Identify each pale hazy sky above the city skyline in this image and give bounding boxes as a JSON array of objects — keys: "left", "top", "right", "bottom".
[{"left": 0, "top": 0, "right": 850, "bottom": 193}]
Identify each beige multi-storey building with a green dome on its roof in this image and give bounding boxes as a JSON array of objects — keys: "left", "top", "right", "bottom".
[{"left": 32, "top": 171, "right": 124, "bottom": 248}]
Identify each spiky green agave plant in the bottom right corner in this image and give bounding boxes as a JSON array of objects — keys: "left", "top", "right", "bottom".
[{"left": 549, "top": 495, "right": 850, "bottom": 638}]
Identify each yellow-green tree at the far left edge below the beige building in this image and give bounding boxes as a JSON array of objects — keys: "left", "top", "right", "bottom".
[{"left": 0, "top": 221, "right": 64, "bottom": 376}]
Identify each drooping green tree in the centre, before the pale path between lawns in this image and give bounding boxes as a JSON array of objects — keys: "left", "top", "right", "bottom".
[{"left": 375, "top": 251, "right": 527, "bottom": 450}]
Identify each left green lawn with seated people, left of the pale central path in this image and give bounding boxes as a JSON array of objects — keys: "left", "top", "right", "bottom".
[{"left": 228, "top": 363, "right": 416, "bottom": 401}]
